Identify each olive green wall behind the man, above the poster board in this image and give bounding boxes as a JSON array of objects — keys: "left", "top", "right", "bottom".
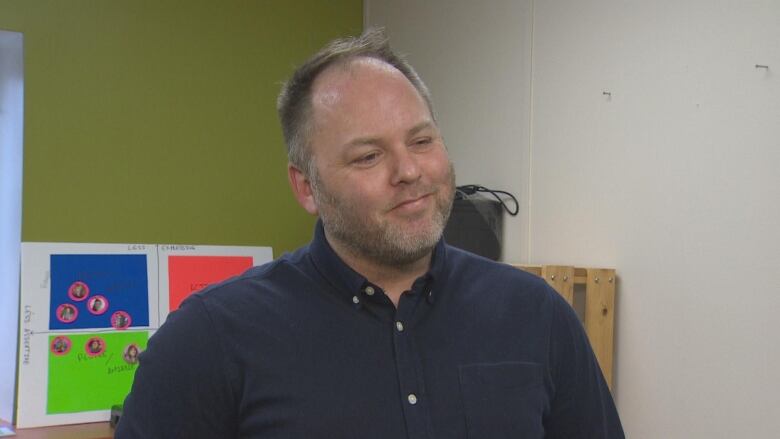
[{"left": 0, "top": 0, "right": 363, "bottom": 256}]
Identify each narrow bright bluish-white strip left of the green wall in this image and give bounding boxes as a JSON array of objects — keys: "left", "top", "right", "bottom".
[{"left": 0, "top": 31, "right": 24, "bottom": 420}]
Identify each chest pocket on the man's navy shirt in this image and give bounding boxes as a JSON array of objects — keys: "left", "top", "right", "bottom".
[{"left": 458, "top": 362, "right": 547, "bottom": 439}]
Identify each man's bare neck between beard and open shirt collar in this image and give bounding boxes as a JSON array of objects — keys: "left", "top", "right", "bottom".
[{"left": 325, "top": 231, "right": 432, "bottom": 307}]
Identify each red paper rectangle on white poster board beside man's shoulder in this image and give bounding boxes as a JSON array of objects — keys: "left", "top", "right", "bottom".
[{"left": 168, "top": 256, "right": 252, "bottom": 311}]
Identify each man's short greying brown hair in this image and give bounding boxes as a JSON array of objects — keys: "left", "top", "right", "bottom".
[{"left": 276, "top": 28, "right": 436, "bottom": 177}]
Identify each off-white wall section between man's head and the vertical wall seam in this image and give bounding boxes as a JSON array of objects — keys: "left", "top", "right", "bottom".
[{"left": 364, "top": 0, "right": 531, "bottom": 262}]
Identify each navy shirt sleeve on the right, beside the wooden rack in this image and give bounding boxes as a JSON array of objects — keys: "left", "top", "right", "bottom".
[{"left": 544, "top": 292, "right": 625, "bottom": 439}]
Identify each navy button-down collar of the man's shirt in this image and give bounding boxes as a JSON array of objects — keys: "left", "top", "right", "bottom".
[{"left": 309, "top": 219, "right": 447, "bottom": 303}]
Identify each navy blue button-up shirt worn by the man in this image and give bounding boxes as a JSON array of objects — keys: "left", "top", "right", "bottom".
[{"left": 116, "top": 224, "right": 623, "bottom": 439}]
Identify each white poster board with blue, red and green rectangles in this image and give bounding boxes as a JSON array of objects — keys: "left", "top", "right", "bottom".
[{"left": 16, "top": 243, "right": 272, "bottom": 428}]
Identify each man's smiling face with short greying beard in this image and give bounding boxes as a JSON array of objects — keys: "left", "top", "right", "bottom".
[{"left": 302, "top": 58, "right": 454, "bottom": 265}]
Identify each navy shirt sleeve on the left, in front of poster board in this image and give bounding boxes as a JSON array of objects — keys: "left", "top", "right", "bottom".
[{"left": 115, "top": 296, "right": 237, "bottom": 439}]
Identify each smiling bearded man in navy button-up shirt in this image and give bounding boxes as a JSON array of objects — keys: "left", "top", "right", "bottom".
[{"left": 116, "top": 32, "right": 623, "bottom": 439}]
